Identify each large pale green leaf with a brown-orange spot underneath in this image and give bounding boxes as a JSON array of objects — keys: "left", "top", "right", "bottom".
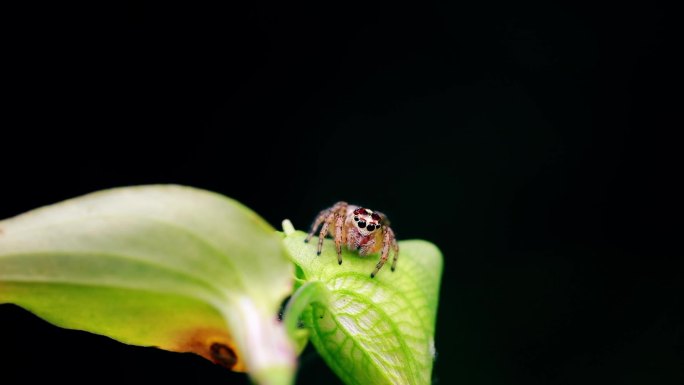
[{"left": 0, "top": 185, "right": 296, "bottom": 384}]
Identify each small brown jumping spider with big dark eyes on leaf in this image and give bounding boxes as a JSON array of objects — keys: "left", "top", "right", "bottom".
[{"left": 305, "top": 202, "right": 399, "bottom": 278}]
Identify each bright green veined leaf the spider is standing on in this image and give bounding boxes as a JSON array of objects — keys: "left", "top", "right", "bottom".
[{"left": 283, "top": 221, "right": 442, "bottom": 385}]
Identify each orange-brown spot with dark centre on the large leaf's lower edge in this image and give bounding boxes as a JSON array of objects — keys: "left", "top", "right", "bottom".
[{"left": 170, "top": 328, "right": 246, "bottom": 372}]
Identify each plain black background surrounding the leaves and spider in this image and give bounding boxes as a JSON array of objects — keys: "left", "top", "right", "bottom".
[{"left": 0, "top": 2, "right": 684, "bottom": 384}]
